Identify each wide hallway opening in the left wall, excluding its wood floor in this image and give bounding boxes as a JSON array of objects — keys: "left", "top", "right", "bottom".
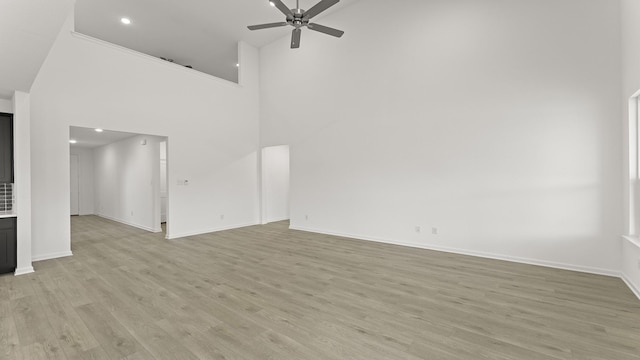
[{"left": 69, "top": 126, "right": 169, "bottom": 245}]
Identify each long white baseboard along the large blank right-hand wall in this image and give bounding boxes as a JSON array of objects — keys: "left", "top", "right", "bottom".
[{"left": 289, "top": 226, "right": 620, "bottom": 277}]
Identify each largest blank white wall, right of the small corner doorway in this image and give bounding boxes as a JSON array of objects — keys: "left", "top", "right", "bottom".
[{"left": 260, "top": 0, "right": 624, "bottom": 274}]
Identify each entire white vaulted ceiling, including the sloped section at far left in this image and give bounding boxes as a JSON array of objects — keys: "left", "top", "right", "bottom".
[{"left": 0, "top": 0, "right": 359, "bottom": 98}]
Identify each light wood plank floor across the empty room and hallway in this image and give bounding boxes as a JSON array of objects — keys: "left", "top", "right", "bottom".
[{"left": 0, "top": 216, "right": 640, "bottom": 360}]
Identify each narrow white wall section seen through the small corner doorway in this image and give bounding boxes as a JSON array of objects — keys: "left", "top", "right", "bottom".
[{"left": 262, "top": 145, "right": 289, "bottom": 224}]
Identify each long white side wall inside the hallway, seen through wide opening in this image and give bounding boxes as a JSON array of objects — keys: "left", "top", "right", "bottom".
[{"left": 93, "top": 135, "right": 164, "bottom": 232}]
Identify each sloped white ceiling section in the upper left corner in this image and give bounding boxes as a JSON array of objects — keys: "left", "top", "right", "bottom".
[{"left": 0, "top": 0, "right": 74, "bottom": 99}]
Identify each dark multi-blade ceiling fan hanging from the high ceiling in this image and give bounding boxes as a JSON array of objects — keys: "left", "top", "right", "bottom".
[{"left": 247, "top": 0, "right": 344, "bottom": 49}]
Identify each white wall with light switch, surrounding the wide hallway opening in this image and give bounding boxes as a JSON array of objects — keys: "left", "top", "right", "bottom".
[{"left": 31, "top": 12, "right": 259, "bottom": 259}]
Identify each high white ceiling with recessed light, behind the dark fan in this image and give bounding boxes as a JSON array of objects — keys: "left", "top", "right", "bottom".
[{"left": 75, "top": 0, "right": 359, "bottom": 81}]
